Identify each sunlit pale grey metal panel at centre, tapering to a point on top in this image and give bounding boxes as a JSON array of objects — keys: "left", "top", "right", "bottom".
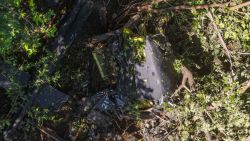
[{"left": 135, "top": 36, "right": 170, "bottom": 102}]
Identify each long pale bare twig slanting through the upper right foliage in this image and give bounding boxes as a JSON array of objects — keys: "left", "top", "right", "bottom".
[{"left": 207, "top": 10, "right": 234, "bottom": 76}]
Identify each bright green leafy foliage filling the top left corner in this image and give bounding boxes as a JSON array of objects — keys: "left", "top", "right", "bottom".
[{"left": 0, "top": 0, "right": 56, "bottom": 59}]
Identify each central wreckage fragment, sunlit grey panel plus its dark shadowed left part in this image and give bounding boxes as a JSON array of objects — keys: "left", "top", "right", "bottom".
[{"left": 92, "top": 32, "right": 175, "bottom": 107}]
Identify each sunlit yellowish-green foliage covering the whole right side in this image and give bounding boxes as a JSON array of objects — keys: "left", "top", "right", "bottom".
[{"left": 148, "top": 0, "right": 250, "bottom": 141}]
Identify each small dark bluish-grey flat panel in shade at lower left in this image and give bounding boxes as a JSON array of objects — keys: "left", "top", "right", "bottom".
[{"left": 34, "top": 85, "right": 69, "bottom": 110}]
